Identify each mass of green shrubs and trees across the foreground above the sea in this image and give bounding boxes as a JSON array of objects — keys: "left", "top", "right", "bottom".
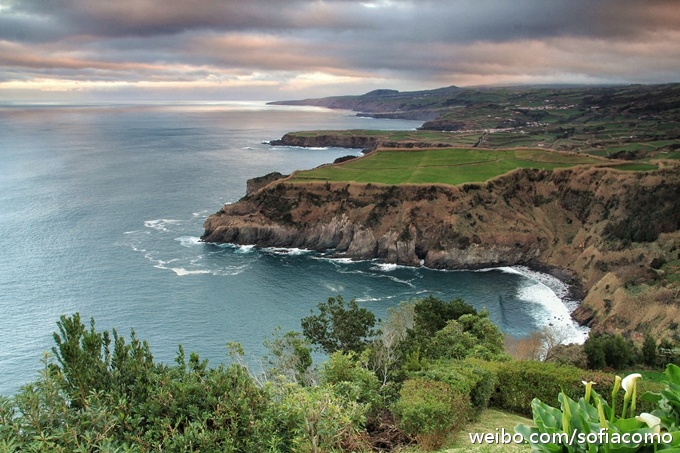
[{"left": 0, "top": 297, "right": 680, "bottom": 452}]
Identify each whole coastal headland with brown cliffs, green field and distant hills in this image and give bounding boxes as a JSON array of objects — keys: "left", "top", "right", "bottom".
[{"left": 209, "top": 84, "right": 680, "bottom": 338}]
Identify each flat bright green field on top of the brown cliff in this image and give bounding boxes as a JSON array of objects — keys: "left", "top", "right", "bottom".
[{"left": 293, "top": 148, "right": 602, "bottom": 185}]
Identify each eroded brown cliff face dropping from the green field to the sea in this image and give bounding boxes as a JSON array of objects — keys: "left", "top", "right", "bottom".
[{"left": 202, "top": 168, "right": 680, "bottom": 333}]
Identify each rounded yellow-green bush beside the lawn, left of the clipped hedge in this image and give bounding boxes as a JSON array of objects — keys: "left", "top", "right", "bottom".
[{"left": 394, "top": 379, "right": 470, "bottom": 450}]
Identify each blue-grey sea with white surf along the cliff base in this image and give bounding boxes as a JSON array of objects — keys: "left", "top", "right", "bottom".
[{"left": 0, "top": 103, "right": 582, "bottom": 394}]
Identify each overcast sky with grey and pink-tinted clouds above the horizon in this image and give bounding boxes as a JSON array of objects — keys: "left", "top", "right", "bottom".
[{"left": 0, "top": 0, "right": 680, "bottom": 101}]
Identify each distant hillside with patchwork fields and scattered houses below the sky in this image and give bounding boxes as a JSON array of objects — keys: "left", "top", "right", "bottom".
[{"left": 275, "top": 84, "right": 680, "bottom": 161}]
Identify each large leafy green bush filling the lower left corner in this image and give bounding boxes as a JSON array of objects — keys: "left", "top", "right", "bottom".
[{"left": 0, "top": 314, "right": 286, "bottom": 452}]
